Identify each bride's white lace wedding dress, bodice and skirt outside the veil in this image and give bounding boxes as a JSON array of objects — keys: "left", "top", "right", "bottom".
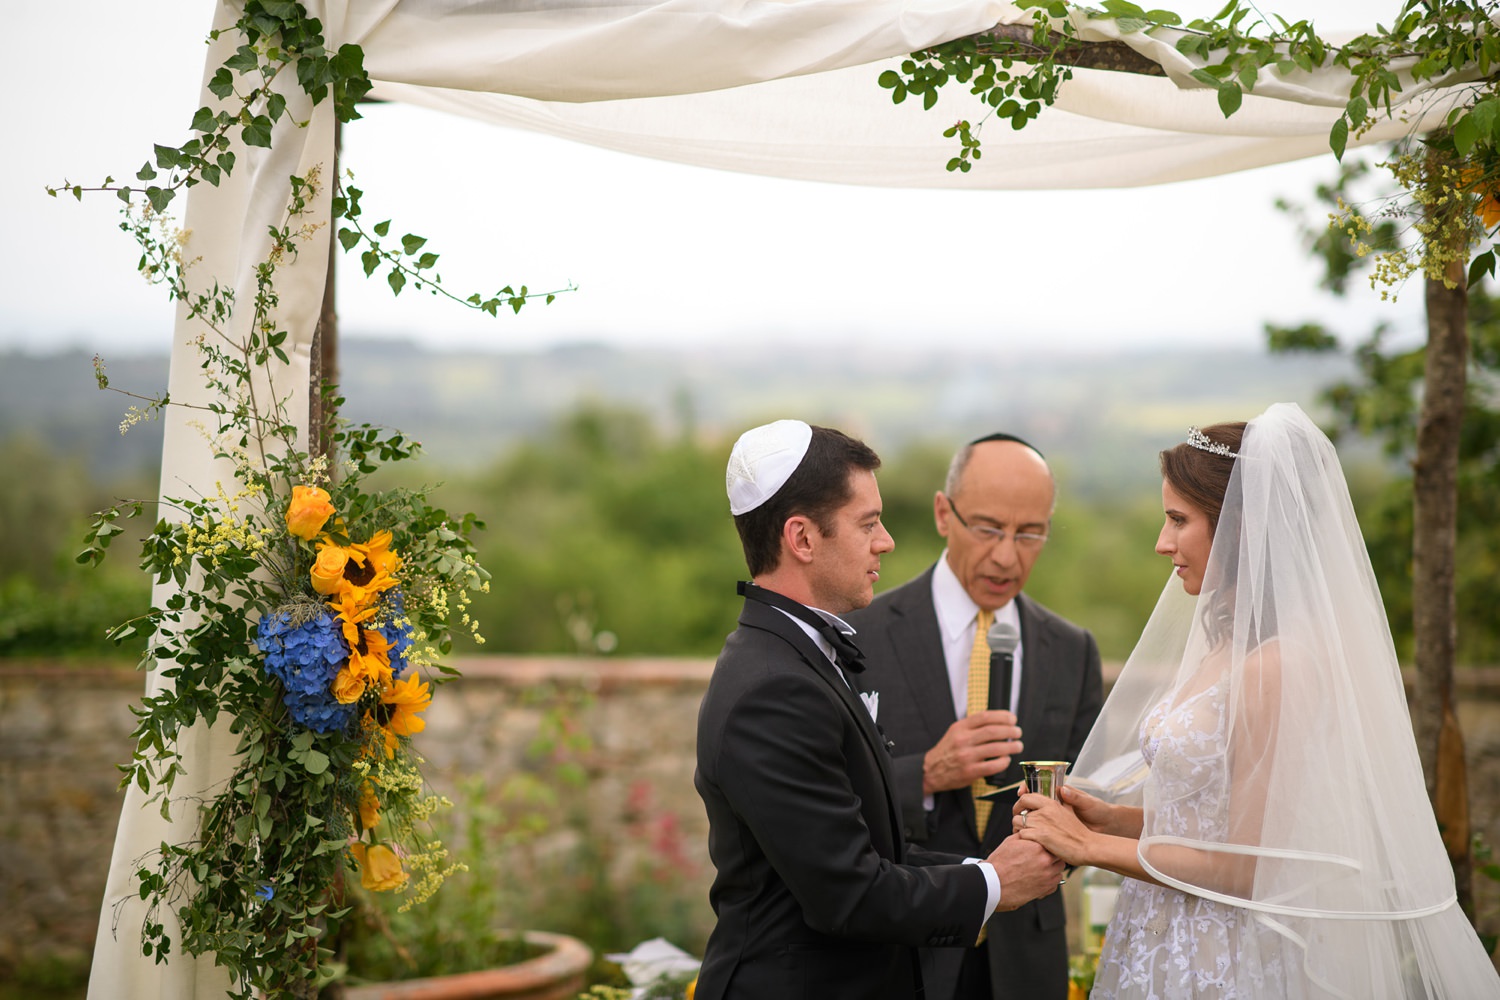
[{"left": 1089, "top": 685, "right": 1287, "bottom": 1000}]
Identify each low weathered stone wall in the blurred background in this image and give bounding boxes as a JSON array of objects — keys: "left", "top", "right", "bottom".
[{"left": 0, "top": 658, "right": 1500, "bottom": 981}]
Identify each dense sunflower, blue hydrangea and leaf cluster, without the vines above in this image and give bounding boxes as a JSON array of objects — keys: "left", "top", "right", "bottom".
[{"left": 80, "top": 320, "right": 488, "bottom": 997}]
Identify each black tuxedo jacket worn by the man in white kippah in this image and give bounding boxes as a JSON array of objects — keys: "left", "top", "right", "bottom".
[{"left": 693, "top": 601, "right": 986, "bottom": 1000}]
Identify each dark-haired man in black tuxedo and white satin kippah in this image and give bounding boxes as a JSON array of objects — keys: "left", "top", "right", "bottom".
[{"left": 695, "top": 420, "right": 1062, "bottom": 1000}]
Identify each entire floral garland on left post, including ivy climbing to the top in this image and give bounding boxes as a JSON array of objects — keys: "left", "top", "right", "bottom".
[{"left": 64, "top": 0, "right": 557, "bottom": 1000}]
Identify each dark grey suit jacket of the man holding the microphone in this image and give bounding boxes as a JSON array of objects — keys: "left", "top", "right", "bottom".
[{"left": 846, "top": 568, "right": 1103, "bottom": 1000}]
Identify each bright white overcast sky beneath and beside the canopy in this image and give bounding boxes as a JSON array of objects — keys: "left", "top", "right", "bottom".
[{"left": 0, "top": 0, "right": 1421, "bottom": 359}]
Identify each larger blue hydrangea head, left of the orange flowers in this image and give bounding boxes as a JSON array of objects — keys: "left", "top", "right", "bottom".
[{"left": 255, "top": 609, "right": 354, "bottom": 733}]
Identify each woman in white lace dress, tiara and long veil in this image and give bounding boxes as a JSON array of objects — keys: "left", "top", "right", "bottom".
[{"left": 1014, "top": 403, "right": 1500, "bottom": 1000}]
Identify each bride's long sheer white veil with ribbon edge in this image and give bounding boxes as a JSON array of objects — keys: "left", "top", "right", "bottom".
[{"left": 1076, "top": 403, "right": 1500, "bottom": 999}]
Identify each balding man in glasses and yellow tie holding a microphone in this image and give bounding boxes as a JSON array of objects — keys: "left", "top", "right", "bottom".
[{"left": 851, "top": 433, "right": 1103, "bottom": 1000}]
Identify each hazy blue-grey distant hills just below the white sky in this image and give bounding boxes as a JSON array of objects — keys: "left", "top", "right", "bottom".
[{"left": 0, "top": 340, "right": 1350, "bottom": 495}]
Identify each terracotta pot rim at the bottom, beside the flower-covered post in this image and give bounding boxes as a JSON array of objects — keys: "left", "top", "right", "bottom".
[{"left": 344, "top": 931, "right": 594, "bottom": 1000}]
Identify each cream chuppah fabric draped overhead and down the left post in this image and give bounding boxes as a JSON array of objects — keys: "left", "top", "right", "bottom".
[{"left": 89, "top": 0, "right": 1455, "bottom": 1000}]
